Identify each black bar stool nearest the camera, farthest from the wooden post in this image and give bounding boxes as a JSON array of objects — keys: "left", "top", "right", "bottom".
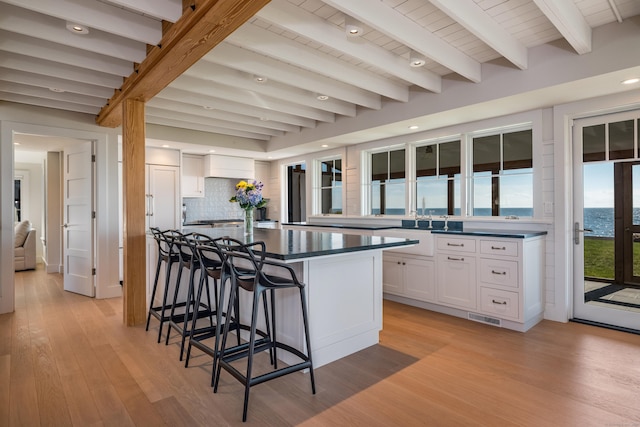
[{"left": 213, "top": 238, "right": 316, "bottom": 422}]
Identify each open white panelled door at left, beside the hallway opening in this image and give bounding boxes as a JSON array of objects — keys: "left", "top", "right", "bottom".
[{"left": 62, "top": 141, "right": 95, "bottom": 297}]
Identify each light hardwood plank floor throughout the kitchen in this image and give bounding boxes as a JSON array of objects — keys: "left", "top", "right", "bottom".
[{"left": 0, "top": 270, "right": 640, "bottom": 426}]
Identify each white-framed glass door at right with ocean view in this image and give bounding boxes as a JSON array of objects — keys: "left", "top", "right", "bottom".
[{"left": 573, "top": 111, "right": 640, "bottom": 330}]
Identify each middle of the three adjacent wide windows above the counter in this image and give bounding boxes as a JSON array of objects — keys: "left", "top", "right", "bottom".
[{"left": 415, "top": 140, "right": 460, "bottom": 215}]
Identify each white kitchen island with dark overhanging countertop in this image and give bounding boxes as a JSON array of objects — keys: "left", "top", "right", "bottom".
[{"left": 183, "top": 228, "right": 418, "bottom": 367}]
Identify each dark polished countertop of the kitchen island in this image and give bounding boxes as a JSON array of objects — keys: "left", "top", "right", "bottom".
[{"left": 183, "top": 227, "right": 419, "bottom": 261}]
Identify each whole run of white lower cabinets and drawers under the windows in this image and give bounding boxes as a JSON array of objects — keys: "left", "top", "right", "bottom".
[{"left": 383, "top": 234, "right": 545, "bottom": 332}]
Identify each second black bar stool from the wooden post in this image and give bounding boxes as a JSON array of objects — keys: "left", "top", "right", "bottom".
[{"left": 165, "top": 233, "right": 215, "bottom": 361}]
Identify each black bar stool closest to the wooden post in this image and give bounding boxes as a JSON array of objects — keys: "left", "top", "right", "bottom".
[{"left": 145, "top": 227, "right": 180, "bottom": 342}]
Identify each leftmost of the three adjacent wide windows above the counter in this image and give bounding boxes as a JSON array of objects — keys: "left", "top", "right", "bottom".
[{"left": 369, "top": 148, "right": 406, "bottom": 215}]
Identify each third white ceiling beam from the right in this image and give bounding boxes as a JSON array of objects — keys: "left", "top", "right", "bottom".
[{"left": 322, "top": 0, "right": 481, "bottom": 83}]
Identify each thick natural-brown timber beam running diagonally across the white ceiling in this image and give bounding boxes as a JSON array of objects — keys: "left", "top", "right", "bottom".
[{"left": 96, "top": 0, "right": 269, "bottom": 127}]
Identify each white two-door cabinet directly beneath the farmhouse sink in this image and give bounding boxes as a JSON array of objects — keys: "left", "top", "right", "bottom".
[{"left": 382, "top": 253, "right": 436, "bottom": 302}]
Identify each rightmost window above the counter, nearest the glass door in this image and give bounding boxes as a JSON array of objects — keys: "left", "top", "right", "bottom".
[{"left": 472, "top": 129, "right": 533, "bottom": 217}]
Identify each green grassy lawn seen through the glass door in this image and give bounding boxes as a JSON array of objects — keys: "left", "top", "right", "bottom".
[{"left": 584, "top": 237, "right": 640, "bottom": 279}]
